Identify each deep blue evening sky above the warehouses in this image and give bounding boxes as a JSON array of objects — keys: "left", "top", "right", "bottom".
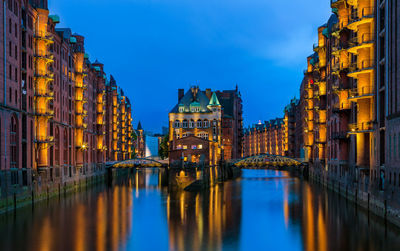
[{"left": 49, "top": 0, "right": 331, "bottom": 132}]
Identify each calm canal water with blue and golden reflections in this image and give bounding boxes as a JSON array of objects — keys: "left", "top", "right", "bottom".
[{"left": 0, "top": 169, "right": 400, "bottom": 251}]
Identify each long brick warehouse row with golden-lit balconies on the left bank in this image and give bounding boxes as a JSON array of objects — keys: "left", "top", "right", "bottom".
[{"left": 0, "top": 0, "right": 134, "bottom": 198}]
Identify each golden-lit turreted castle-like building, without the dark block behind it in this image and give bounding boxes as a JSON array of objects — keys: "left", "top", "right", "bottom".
[{"left": 169, "top": 86, "right": 221, "bottom": 165}]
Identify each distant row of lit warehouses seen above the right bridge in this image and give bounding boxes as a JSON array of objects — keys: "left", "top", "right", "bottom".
[{"left": 243, "top": 118, "right": 285, "bottom": 157}]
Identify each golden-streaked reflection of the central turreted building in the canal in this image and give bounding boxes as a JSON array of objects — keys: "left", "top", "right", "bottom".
[{"left": 167, "top": 185, "right": 242, "bottom": 250}]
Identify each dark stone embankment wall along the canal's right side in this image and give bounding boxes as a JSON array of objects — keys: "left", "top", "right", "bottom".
[{"left": 308, "top": 168, "right": 400, "bottom": 227}]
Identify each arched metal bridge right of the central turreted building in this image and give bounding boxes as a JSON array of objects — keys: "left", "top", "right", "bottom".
[{"left": 234, "top": 154, "right": 302, "bottom": 168}]
